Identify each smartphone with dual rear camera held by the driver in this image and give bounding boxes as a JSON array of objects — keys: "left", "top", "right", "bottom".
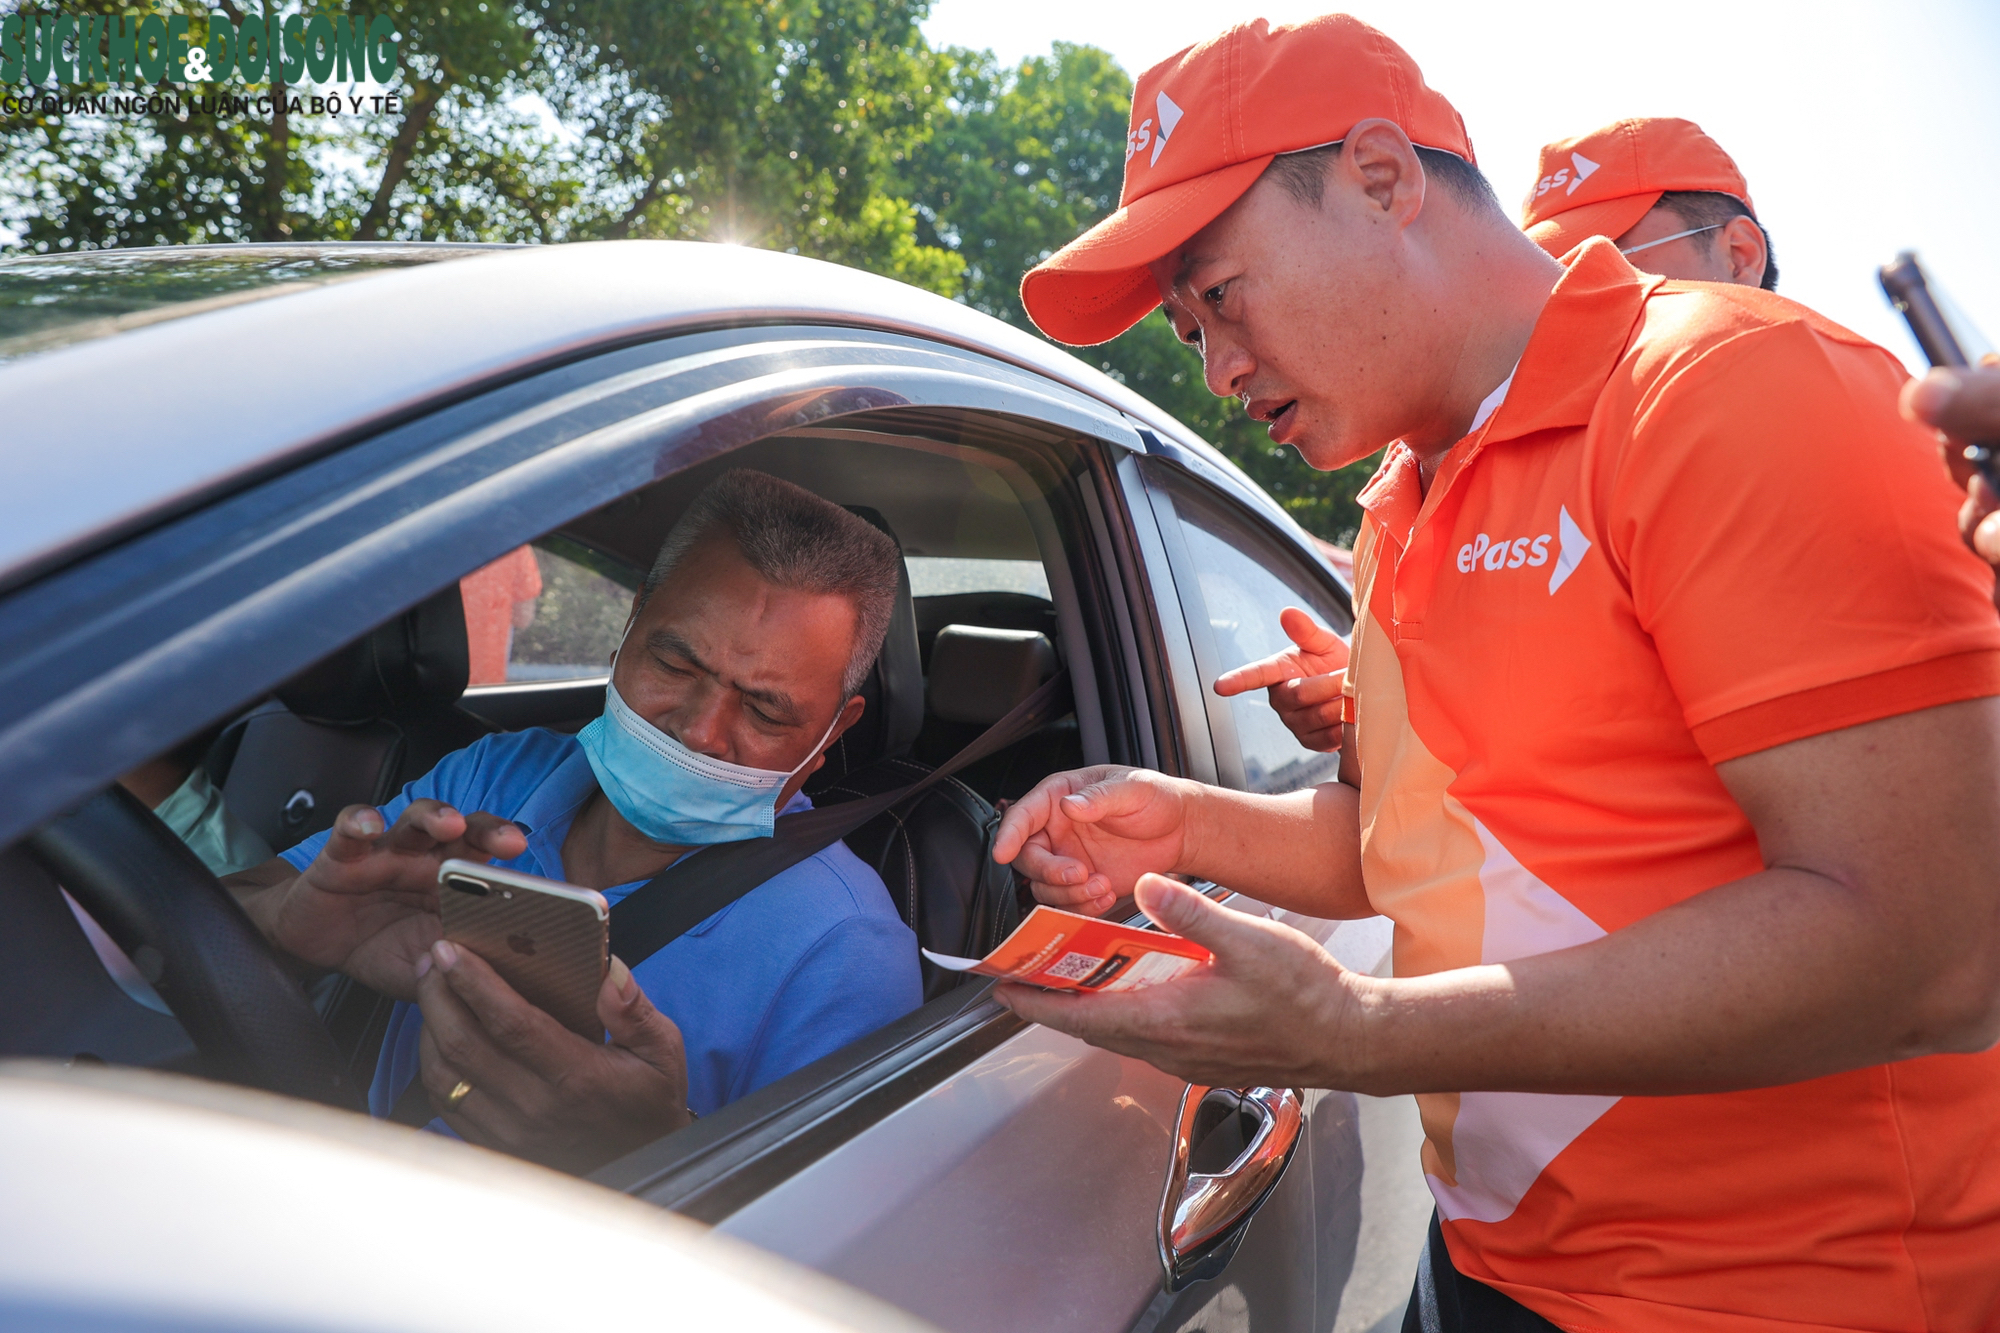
[{"left": 438, "top": 859, "right": 612, "bottom": 1041}]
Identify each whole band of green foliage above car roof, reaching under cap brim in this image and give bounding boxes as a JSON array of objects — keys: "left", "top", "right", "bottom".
[{"left": 0, "top": 13, "right": 1370, "bottom": 540}]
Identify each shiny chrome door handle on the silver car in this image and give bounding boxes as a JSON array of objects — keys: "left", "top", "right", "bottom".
[{"left": 1160, "top": 1083, "right": 1306, "bottom": 1291}]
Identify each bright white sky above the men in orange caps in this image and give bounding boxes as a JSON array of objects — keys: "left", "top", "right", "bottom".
[{"left": 924, "top": 0, "right": 2000, "bottom": 366}]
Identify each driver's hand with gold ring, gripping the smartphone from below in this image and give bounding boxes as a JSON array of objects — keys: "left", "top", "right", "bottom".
[{"left": 416, "top": 941, "right": 688, "bottom": 1173}]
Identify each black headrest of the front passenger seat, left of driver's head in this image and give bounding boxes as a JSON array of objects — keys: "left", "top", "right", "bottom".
[{"left": 276, "top": 582, "right": 472, "bottom": 723}]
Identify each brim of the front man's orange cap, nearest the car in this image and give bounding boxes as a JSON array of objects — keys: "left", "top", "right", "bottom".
[{"left": 1020, "top": 156, "right": 1272, "bottom": 346}]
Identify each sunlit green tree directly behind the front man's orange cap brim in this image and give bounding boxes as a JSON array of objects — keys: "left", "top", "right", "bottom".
[{"left": 908, "top": 42, "right": 1374, "bottom": 542}]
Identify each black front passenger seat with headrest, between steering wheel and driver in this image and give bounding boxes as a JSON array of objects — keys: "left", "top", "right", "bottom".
[{"left": 206, "top": 582, "right": 494, "bottom": 851}]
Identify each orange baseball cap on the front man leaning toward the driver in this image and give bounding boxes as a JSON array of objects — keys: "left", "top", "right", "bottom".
[{"left": 1020, "top": 14, "right": 1474, "bottom": 344}]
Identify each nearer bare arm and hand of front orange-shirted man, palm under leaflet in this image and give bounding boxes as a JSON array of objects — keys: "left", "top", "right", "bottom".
[{"left": 1000, "top": 699, "right": 2000, "bottom": 1097}]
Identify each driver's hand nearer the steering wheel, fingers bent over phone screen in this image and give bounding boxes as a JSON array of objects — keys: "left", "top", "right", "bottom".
[{"left": 244, "top": 799, "right": 528, "bottom": 999}]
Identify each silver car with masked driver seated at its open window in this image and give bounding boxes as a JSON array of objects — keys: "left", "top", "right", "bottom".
[{"left": 0, "top": 242, "right": 1428, "bottom": 1333}]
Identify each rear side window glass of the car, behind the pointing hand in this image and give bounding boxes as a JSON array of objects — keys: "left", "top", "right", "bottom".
[{"left": 1168, "top": 474, "right": 1354, "bottom": 793}]
